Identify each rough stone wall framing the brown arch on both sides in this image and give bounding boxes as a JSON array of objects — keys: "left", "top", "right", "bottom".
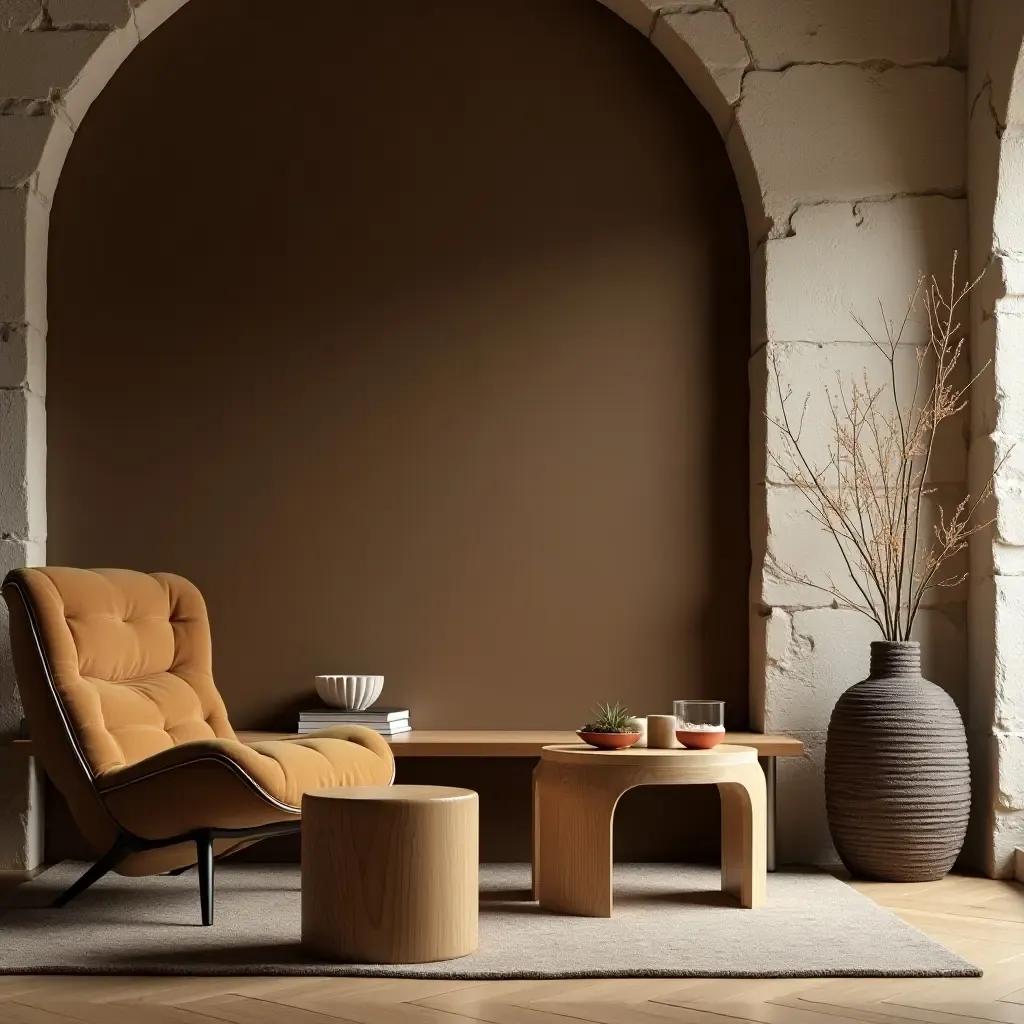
[{"left": 0, "top": 0, "right": 1003, "bottom": 866}]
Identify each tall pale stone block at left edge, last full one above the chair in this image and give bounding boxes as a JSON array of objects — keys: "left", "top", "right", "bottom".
[{"left": 0, "top": 390, "right": 46, "bottom": 541}]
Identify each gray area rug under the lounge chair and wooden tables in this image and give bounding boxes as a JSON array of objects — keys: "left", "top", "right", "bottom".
[{"left": 0, "top": 862, "right": 981, "bottom": 980}]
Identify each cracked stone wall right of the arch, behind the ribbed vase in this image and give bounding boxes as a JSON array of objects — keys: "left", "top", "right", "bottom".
[{"left": 622, "top": 0, "right": 967, "bottom": 861}]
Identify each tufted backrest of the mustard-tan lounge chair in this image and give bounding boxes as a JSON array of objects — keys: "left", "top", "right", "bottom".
[{"left": 4, "top": 568, "right": 236, "bottom": 776}]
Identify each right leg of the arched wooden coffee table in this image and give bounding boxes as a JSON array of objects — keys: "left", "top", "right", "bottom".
[{"left": 718, "top": 764, "right": 768, "bottom": 908}]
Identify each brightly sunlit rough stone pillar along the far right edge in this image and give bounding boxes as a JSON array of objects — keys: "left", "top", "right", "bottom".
[{"left": 968, "top": 0, "right": 1024, "bottom": 877}]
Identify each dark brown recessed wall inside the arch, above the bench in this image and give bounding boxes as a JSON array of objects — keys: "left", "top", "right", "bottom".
[{"left": 48, "top": 0, "right": 749, "bottom": 728}]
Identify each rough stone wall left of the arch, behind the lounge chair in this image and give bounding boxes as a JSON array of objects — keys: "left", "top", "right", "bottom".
[{"left": 0, "top": 0, "right": 184, "bottom": 870}]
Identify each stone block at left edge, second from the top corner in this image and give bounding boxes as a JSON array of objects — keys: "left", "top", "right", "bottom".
[{"left": 0, "top": 31, "right": 106, "bottom": 99}]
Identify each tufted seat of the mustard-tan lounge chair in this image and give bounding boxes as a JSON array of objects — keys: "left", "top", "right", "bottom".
[{"left": 96, "top": 726, "right": 394, "bottom": 839}]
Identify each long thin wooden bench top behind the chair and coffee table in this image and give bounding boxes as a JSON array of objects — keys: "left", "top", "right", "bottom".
[{"left": 13, "top": 729, "right": 804, "bottom": 758}]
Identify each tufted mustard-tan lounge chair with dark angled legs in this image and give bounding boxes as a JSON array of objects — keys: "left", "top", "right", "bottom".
[{"left": 3, "top": 568, "right": 394, "bottom": 925}]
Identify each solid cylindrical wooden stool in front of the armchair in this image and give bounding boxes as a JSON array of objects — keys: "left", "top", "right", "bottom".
[{"left": 302, "top": 785, "right": 479, "bottom": 964}]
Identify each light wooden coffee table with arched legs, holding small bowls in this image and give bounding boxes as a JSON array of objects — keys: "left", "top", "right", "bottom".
[{"left": 534, "top": 743, "right": 767, "bottom": 918}]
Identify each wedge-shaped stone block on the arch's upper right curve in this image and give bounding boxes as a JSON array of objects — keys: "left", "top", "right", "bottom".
[{"left": 650, "top": 10, "right": 751, "bottom": 136}]
